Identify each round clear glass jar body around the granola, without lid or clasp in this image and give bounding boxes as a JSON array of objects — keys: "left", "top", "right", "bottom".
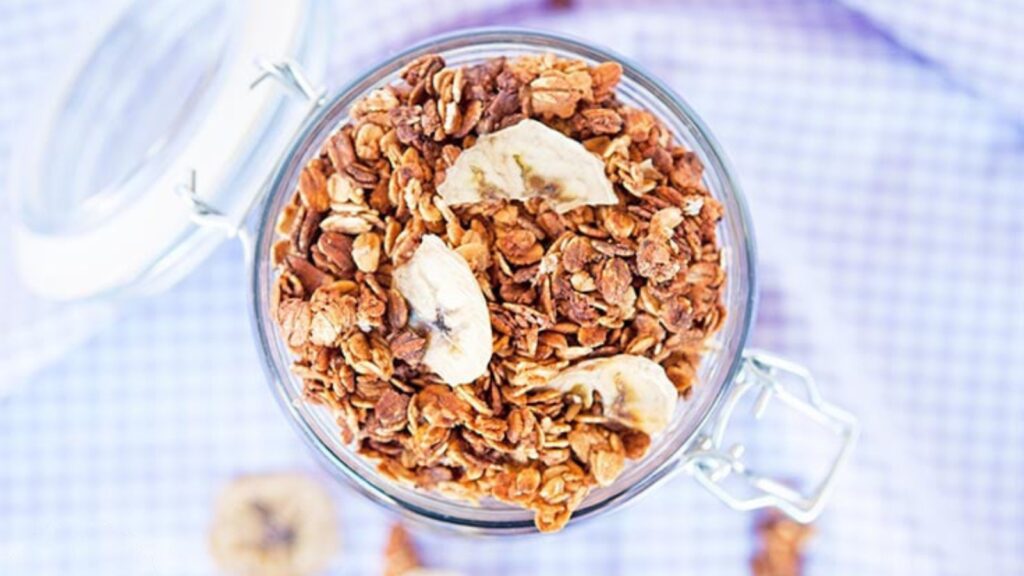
[{"left": 250, "top": 30, "right": 756, "bottom": 534}]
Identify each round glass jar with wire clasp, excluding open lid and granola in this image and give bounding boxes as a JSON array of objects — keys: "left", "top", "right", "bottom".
[{"left": 250, "top": 29, "right": 857, "bottom": 535}]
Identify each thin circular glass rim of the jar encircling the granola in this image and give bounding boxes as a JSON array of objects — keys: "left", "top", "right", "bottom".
[{"left": 249, "top": 27, "right": 758, "bottom": 534}]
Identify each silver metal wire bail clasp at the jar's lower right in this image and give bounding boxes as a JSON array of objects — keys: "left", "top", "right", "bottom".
[{"left": 684, "top": 352, "right": 859, "bottom": 523}]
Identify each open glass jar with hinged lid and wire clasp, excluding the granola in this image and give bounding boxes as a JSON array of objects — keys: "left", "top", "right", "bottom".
[{"left": 10, "top": 0, "right": 857, "bottom": 534}]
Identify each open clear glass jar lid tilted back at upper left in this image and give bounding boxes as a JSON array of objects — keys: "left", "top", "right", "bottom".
[{"left": 9, "top": 0, "right": 329, "bottom": 299}]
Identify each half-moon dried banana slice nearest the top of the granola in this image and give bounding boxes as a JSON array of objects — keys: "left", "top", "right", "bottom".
[{"left": 437, "top": 120, "right": 618, "bottom": 212}]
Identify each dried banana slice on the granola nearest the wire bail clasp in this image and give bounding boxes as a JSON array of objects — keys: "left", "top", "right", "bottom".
[{"left": 549, "top": 354, "right": 679, "bottom": 435}]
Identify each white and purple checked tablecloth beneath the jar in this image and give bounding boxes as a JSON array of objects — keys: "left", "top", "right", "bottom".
[{"left": 0, "top": 0, "right": 1024, "bottom": 576}]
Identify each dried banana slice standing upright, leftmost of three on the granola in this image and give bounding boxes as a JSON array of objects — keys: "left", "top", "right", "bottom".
[{"left": 392, "top": 234, "right": 494, "bottom": 386}]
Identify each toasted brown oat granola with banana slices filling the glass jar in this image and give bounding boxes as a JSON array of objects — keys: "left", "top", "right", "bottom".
[{"left": 272, "top": 54, "right": 725, "bottom": 531}]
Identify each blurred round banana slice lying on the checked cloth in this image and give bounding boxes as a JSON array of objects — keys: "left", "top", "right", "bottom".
[{"left": 210, "top": 474, "right": 338, "bottom": 576}]
